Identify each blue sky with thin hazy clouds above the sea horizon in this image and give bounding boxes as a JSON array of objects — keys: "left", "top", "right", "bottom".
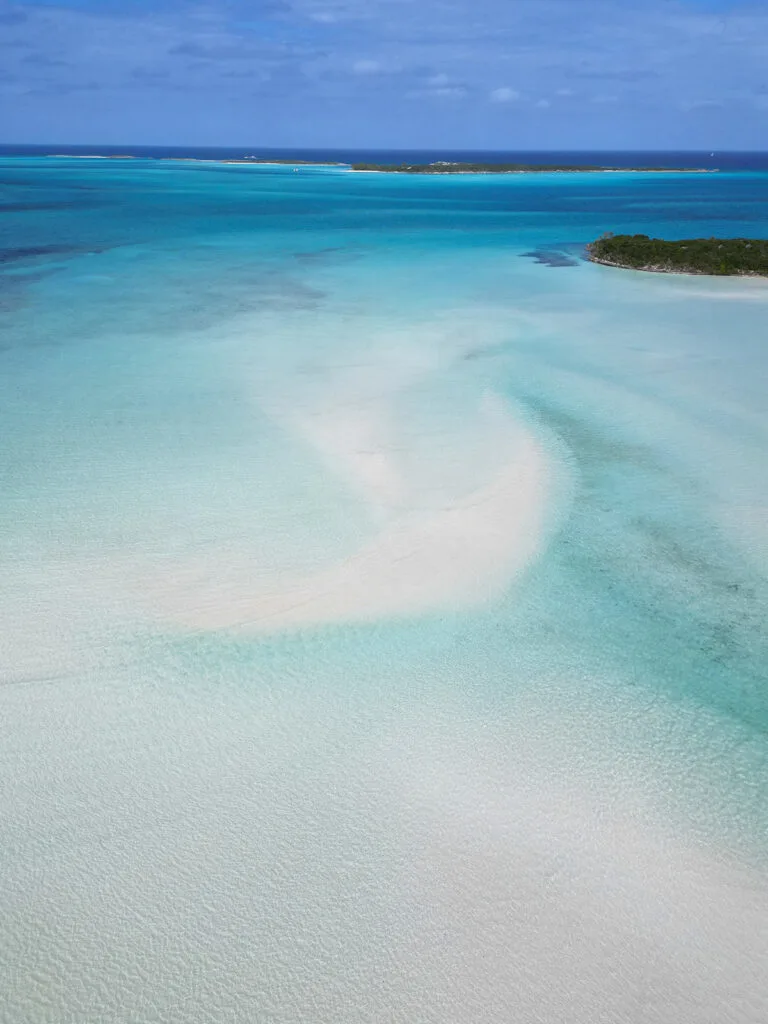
[{"left": 0, "top": 0, "right": 768, "bottom": 150}]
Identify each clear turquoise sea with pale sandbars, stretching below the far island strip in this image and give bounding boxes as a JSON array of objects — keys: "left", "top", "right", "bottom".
[{"left": 0, "top": 158, "right": 768, "bottom": 1024}]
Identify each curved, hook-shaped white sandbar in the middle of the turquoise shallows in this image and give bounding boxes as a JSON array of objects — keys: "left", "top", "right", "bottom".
[{"left": 138, "top": 376, "right": 547, "bottom": 632}]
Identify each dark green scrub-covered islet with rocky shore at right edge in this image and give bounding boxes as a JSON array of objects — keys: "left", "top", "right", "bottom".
[{"left": 587, "top": 232, "right": 768, "bottom": 278}]
